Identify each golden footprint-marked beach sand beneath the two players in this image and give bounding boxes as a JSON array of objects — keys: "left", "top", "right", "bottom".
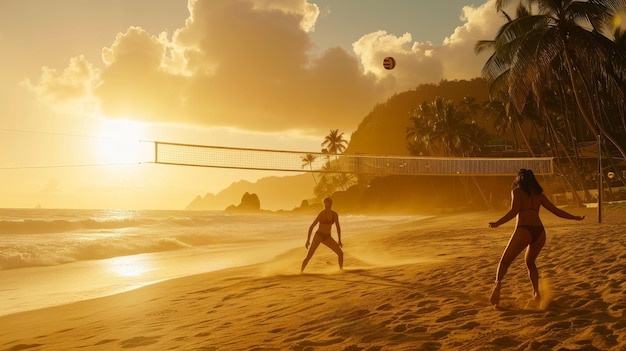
[{"left": 0, "top": 208, "right": 626, "bottom": 351}]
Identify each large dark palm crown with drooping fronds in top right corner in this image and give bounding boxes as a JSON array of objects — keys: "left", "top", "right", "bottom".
[{"left": 475, "top": 0, "right": 626, "bottom": 202}]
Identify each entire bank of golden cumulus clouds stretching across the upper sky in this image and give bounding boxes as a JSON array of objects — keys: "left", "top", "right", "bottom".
[{"left": 26, "top": 0, "right": 502, "bottom": 132}]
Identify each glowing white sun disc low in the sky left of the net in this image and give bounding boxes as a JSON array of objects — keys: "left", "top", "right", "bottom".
[{"left": 96, "top": 119, "right": 152, "bottom": 163}]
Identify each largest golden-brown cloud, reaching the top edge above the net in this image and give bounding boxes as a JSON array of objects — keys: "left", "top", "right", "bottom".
[{"left": 166, "top": 1, "right": 384, "bottom": 131}]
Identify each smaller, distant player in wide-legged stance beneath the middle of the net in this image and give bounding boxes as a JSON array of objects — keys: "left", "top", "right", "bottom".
[{"left": 300, "top": 197, "right": 343, "bottom": 273}]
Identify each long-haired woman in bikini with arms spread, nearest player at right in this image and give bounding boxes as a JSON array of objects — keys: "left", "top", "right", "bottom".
[{"left": 489, "top": 169, "right": 585, "bottom": 305}]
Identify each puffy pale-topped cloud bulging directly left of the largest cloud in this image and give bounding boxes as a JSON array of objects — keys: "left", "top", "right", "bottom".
[{"left": 94, "top": 27, "right": 184, "bottom": 122}]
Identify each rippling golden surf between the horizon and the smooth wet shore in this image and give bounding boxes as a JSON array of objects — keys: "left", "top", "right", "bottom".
[{"left": 0, "top": 210, "right": 415, "bottom": 270}]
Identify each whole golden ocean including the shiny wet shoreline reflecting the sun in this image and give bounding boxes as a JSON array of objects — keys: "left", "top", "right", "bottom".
[{"left": 0, "top": 209, "right": 416, "bottom": 315}]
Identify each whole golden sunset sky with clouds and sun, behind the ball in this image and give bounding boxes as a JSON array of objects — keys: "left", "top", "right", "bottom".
[{"left": 0, "top": 0, "right": 504, "bottom": 209}]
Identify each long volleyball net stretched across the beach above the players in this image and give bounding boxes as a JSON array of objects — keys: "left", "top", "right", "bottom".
[{"left": 154, "top": 141, "right": 554, "bottom": 176}]
